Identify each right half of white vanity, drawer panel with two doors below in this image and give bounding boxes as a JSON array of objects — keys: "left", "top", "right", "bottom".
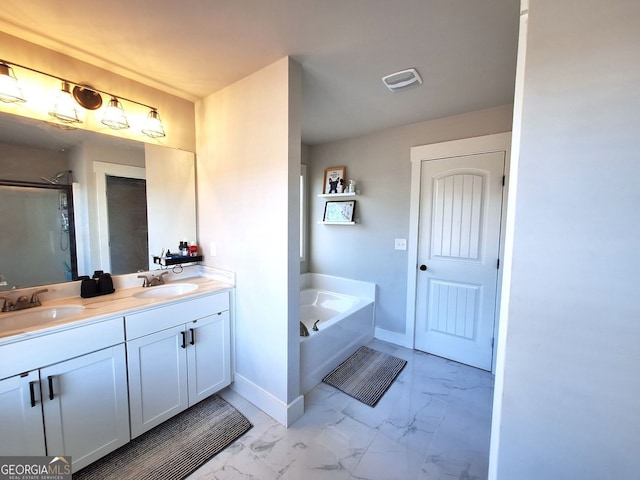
[{"left": 125, "top": 292, "right": 231, "bottom": 438}]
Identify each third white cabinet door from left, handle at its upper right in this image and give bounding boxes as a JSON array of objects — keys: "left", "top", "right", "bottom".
[{"left": 127, "top": 325, "right": 189, "bottom": 438}]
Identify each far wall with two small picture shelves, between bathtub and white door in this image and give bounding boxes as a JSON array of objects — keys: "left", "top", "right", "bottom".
[{"left": 308, "top": 106, "right": 512, "bottom": 346}]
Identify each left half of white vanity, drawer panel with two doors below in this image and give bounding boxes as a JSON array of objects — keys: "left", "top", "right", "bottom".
[{"left": 0, "top": 318, "right": 129, "bottom": 471}]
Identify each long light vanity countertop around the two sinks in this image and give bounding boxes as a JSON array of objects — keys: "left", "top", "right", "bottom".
[{"left": 0, "top": 277, "right": 234, "bottom": 345}]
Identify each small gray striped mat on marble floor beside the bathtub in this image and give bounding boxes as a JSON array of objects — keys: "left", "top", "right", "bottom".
[{"left": 322, "top": 346, "right": 407, "bottom": 407}]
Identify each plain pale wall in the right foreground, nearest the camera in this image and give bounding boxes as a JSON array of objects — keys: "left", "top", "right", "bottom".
[{"left": 490, "top": 0, "right": 640, "bottom": 480}]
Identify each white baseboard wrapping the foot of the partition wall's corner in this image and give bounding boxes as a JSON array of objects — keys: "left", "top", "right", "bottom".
[{"left": 230, "top": 373, "right": 304, "bottom": 427}]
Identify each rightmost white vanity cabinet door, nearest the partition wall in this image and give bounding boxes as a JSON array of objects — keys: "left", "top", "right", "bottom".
[{"left": 187, "top": 311, "right": 231, "bottom": 405}]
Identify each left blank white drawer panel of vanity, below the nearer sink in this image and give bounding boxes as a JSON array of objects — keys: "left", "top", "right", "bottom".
[{"left": 0, "top": 317, "right": 124, "bottom": 378}]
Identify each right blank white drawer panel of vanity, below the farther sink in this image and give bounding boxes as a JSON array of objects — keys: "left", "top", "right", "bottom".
[{"left": 125, "top": 287, "right": 229, "bottom": 340}]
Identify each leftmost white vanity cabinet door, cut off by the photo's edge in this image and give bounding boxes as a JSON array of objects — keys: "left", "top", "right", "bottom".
[{"left": 0, "top": 370, "right": 46, "bottom": 456}]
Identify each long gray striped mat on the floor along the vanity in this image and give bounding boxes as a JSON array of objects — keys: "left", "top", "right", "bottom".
[{"left": 73, "top": 395, "right": 252, "bottom": 480}]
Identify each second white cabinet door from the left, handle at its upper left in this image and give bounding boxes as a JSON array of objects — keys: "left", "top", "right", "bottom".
[{"left": 40, "top": 344, "right": 129, "bottom": 471}]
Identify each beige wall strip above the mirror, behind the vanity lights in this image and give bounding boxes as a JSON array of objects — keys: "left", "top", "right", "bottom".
[{"left": 0, "top": 32, "right": 195, "bottom": 152}]
